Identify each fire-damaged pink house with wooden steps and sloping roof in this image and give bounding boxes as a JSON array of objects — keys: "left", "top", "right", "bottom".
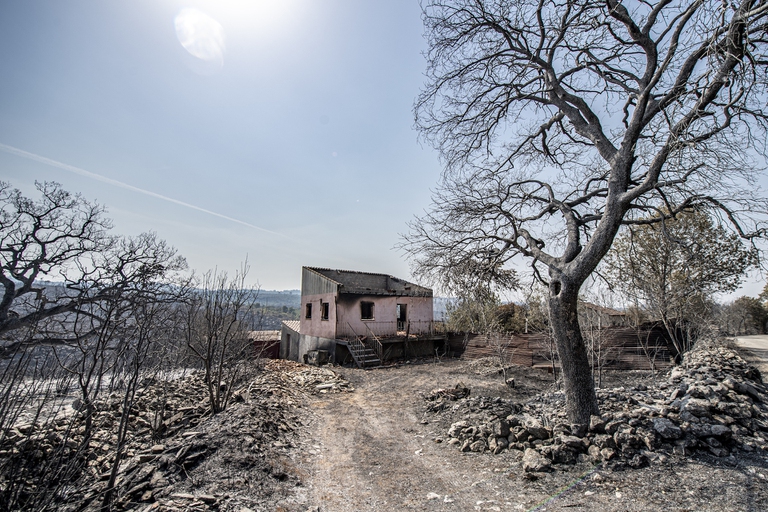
[{"left": 280, "top": 267, "right": 442, "bottom": 366}]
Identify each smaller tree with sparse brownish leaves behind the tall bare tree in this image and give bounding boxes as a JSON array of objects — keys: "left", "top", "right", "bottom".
[{"left": 604, "top": 210, "right": 758, "bottom": 353}]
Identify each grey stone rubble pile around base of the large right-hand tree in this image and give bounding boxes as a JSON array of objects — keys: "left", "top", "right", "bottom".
[{"left": 427, "top": 347, "right": 768, "bottom": 472}]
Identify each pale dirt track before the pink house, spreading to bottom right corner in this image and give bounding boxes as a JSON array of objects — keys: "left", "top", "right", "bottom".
[{"left": 301, "top": 362, "right": 768, "bottom": 512}]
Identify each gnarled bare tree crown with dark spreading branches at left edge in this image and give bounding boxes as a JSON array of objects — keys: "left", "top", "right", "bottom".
[{"left": 0, "top": 182, "right": 186, "bottom": 350}]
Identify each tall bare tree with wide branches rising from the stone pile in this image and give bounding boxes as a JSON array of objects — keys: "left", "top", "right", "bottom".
[{"left": 405, "top": 0, "right": 768, "bottom": 422}]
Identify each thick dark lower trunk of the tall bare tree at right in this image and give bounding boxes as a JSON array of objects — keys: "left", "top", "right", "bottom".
[{"left": 549, "top": 279, "right": 599, "bottom": 425}]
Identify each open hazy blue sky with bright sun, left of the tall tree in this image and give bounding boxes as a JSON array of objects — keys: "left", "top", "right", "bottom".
[{"left": 0, "top": 0, "right": 440, "bottom": 289}]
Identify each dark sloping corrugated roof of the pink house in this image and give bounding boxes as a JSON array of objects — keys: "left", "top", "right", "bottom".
[{"left": 304, "top": 267, "right": 432, "bottom": 297}]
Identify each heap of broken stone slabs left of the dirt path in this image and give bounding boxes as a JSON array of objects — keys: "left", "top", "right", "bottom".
[{"left": 0, "top": 361, "right": 344, "bottom": 510}]
